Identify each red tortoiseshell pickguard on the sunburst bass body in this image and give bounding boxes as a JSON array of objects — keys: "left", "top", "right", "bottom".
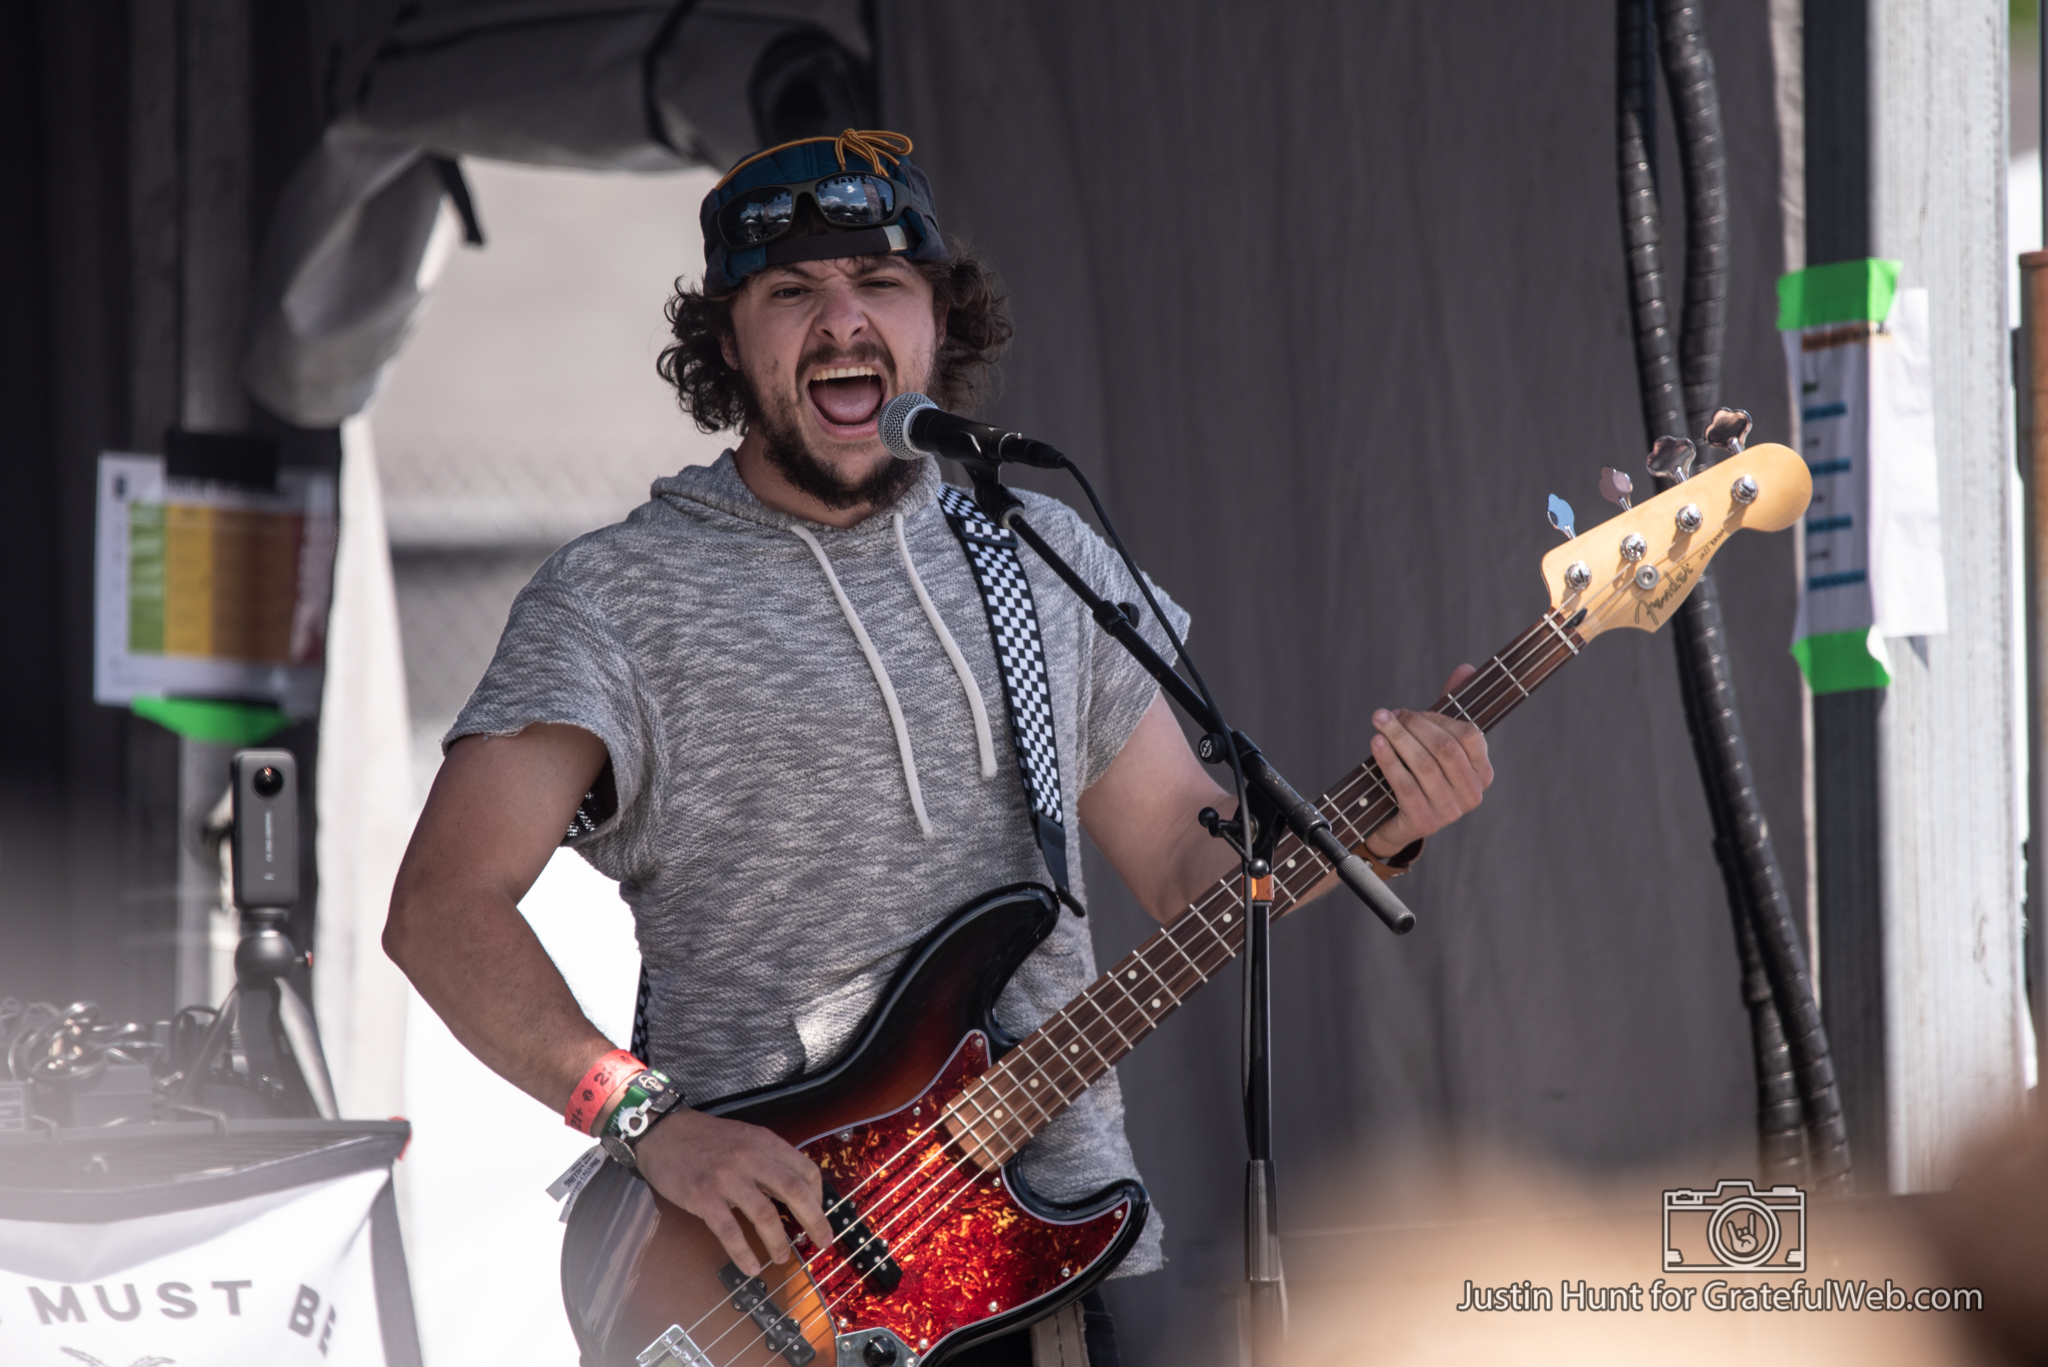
[{"left": 788, "top": 1031, "right": 1130, "bottom": 1357}]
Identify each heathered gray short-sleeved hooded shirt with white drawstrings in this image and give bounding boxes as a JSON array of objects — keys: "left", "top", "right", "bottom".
[{"left": 446, "top": 453, "right": 1186, "bottom": 1275}]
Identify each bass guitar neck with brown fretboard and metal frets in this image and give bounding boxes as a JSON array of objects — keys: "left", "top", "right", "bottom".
[{"left": 948, "top": 611, "right": 1583, "bottom": 1166}]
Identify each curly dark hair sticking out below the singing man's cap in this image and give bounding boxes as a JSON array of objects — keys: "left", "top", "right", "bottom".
[{"left": 655, "top": 227, "right": 1014, "bottom": 432}]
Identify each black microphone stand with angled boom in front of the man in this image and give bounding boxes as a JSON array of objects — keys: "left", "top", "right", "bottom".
[{"left": 961, "top": 457, "right": 1415, "bottom": 1363}]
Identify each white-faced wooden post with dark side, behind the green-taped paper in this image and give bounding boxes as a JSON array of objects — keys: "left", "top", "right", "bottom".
[{"left": 1804, "top": 0, "right": 2032, "bottom": 1191}]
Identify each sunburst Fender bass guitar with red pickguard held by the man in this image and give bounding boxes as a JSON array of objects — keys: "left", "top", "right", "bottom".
[{"left": 561, "top": 445, "right": 1812, "bottom": 1367}]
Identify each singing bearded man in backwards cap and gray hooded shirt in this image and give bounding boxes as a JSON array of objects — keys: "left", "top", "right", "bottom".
[{"left": 385, "top": 131, "right": 1493, "bottom": 1367}]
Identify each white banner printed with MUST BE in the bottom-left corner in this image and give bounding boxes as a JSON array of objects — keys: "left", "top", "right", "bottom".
[{"left": 0, "top": 1168, "right": 391, "bottom": 1367}]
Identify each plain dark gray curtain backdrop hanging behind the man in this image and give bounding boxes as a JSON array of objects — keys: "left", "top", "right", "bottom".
[{"left": 879, "top": 0, "right": 1804, "bottom": 1365}]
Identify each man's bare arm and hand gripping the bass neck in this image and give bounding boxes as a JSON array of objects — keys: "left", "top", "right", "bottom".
[{"left": 1081, "top": 664, "right": 1493, "bottom": 922}]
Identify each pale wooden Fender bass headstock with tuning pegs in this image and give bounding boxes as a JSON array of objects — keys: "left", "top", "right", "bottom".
[{"left": 1542, "top": 443, "right": 1812, "bottom": 639}]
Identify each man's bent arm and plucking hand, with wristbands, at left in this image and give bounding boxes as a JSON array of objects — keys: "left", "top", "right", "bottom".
[{"left": 383, "top": 723, "right": 831, "bottom": 1275}]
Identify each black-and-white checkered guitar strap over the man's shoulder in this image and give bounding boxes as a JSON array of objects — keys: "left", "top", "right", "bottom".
[{"left": 938, "top": 484, "right": 1079, "bottom": 910}]
